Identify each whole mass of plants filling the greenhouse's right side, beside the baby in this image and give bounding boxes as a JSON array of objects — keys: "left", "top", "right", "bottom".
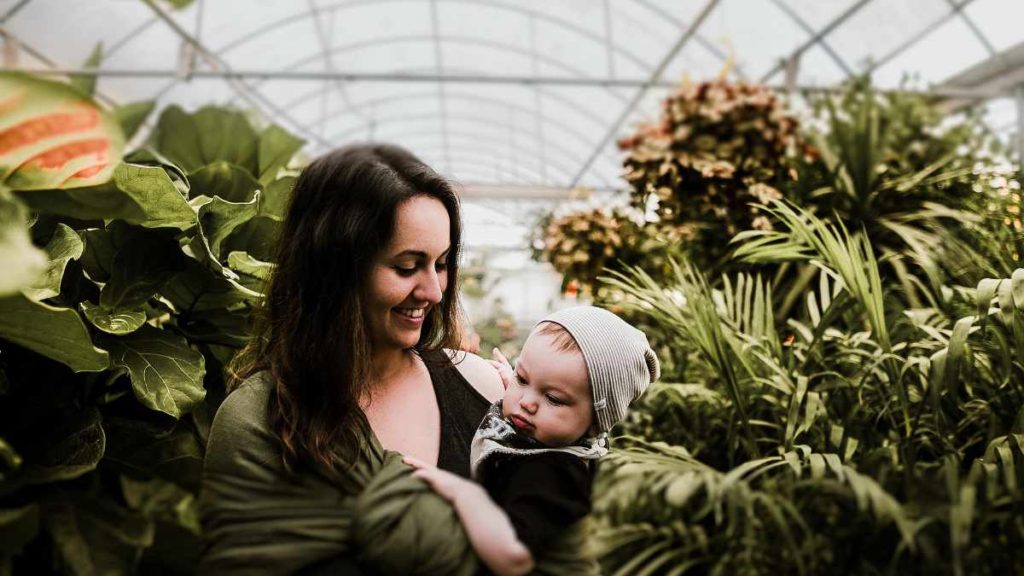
[{"left": 539, "top": 81, "right": 1024, "bottom": 575}]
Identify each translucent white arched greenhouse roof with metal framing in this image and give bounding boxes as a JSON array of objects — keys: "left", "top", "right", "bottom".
[{"left": 0, "top": 0, "right": 1024, "bottom": 200}]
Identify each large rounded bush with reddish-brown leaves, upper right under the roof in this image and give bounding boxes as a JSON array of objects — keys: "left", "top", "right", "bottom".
[{"left": 618, "top": 80, "right": 802, "bottom": 263}]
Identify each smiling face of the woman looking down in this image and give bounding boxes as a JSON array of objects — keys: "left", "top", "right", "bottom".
[{"left": 367, "top": 196, "right": 452, "bottom": 351}]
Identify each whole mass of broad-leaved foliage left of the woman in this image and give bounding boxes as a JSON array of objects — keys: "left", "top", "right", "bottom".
[{"left": 0, "top": 73, "right": 302, "bottom": 574}]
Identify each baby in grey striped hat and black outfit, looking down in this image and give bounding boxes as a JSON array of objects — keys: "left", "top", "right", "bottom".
[{"left": 406, "top": 306, "right": 658, "bottom": 574}]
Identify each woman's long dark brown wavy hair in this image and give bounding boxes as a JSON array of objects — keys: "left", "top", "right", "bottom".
[{"left": 233, "top": 143, "right": 462, "bottom": 480}]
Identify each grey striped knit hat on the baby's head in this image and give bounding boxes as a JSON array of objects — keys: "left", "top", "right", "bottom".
[{"left": 538, "top": 306, "right": 660, "bottom": 433}]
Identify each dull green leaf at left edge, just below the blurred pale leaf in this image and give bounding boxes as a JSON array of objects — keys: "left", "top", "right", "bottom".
[{"left": 0, "top": 295, "right": 110, "bottom": 372}]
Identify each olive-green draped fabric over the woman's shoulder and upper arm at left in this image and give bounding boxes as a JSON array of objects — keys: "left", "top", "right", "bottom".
[{"left": 200, "top": 375, "right": 353, "bottom": 574}]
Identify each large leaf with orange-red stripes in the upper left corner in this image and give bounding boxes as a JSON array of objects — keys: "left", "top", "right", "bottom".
[{"left": 0, "top": 72, "right": 124, "bottom": 190}]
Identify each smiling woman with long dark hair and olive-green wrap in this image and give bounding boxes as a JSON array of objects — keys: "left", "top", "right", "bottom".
[{"left": 200, "top": 145, "right": 503, "bottom": 573}]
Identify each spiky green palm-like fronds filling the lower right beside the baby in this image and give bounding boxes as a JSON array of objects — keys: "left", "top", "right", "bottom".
[{"left": 596, "top": 203, "right": 1024, "bottom": 574}]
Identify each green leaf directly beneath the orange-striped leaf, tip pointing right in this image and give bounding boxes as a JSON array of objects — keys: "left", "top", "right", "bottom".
[{"left": 18, "top": 164, "right": 197, "bottom": 230}]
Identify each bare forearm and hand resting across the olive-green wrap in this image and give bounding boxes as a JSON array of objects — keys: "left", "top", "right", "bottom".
[{"left": 404, "top": 457, "right": 534, "bottom": 576}]
